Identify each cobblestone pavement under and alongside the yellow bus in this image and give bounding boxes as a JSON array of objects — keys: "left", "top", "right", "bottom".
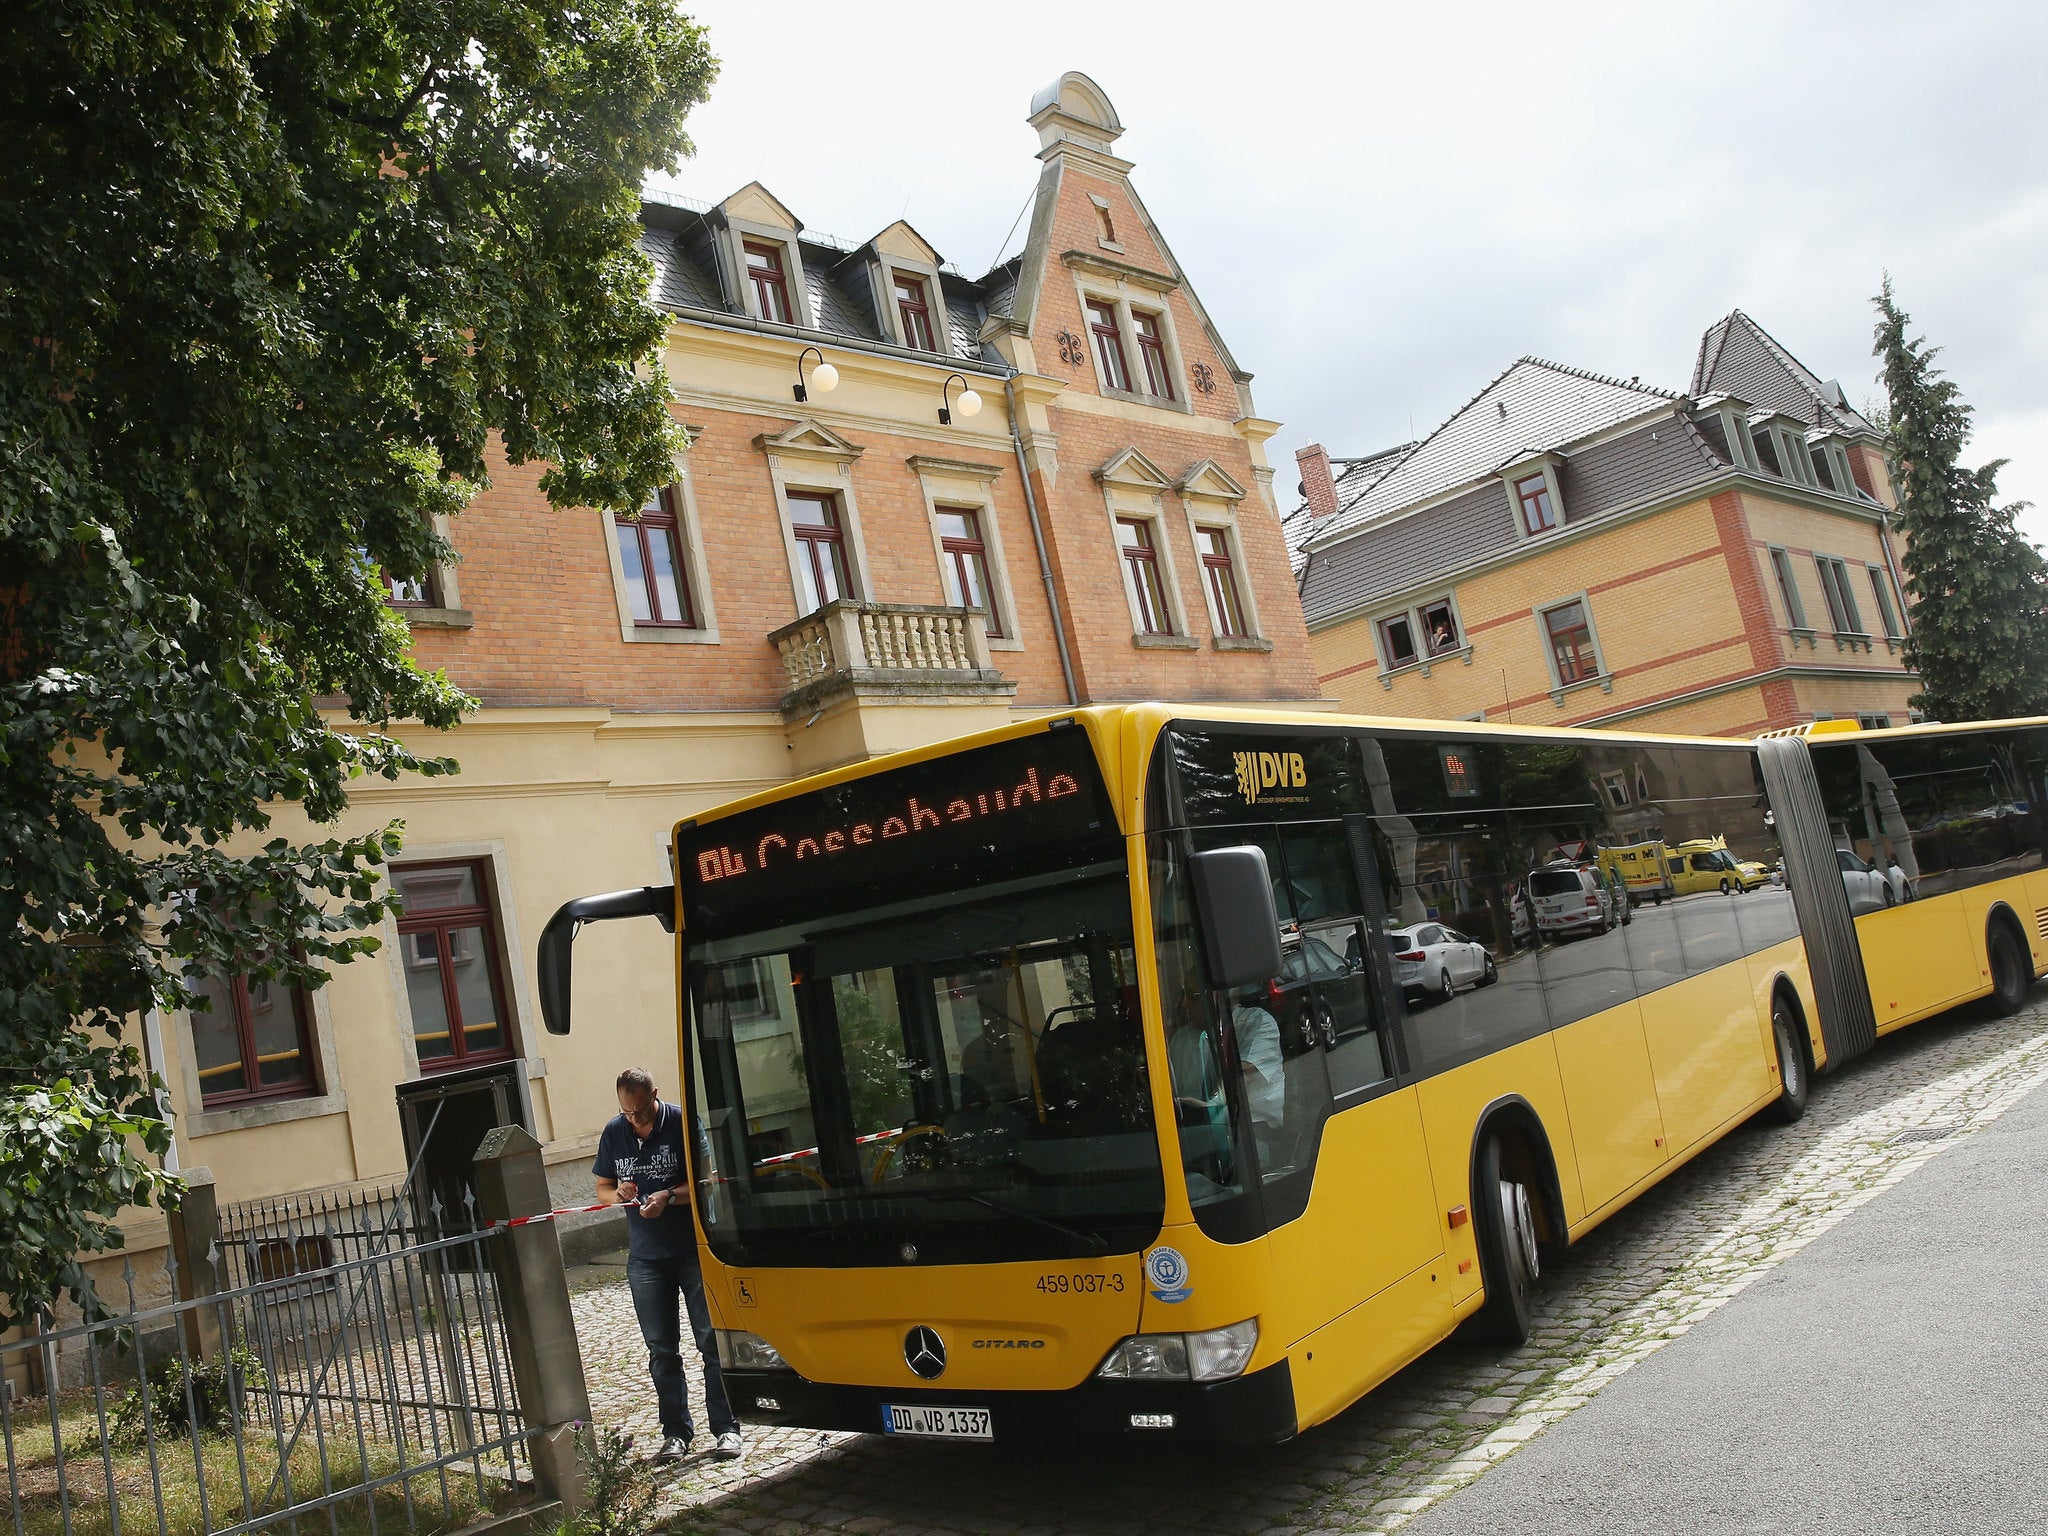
[{"left": 575, "top": 1001, "right": 2048, "bottom": 1536}]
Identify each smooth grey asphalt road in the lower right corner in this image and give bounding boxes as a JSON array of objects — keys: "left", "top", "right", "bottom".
[{"left": 1405, "top": 1064, "right": 2048, "bottom": 1536}]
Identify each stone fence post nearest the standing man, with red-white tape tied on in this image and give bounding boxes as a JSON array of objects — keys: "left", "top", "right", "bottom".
[{"left": 475, "top": 1124, "right": 590, "bottom": 1516}]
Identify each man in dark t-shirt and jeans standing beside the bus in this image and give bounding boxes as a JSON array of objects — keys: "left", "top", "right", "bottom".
[{"left": 590, "top": 1067, "right": 739, "bottom": 1462}]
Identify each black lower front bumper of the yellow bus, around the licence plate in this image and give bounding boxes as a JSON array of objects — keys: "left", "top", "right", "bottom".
[{"left": 723, "top": 1360, "right": 1294, "bottom": 1446}]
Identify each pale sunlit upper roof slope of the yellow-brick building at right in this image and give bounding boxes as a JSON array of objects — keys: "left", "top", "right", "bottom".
[{"left": 1311, "top": 356, "right": 1677, "bottom": 545}]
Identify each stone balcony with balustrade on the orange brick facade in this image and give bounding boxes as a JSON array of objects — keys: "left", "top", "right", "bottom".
[{"left": 768, "top": 598, "right": 1018, "bottom": 729}]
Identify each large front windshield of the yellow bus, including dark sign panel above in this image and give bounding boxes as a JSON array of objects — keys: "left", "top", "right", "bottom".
[{"left": 684, "top": 731, "right": 1163, "bottom": 1266}]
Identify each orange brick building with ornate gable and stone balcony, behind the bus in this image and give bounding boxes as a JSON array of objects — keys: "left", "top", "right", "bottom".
[{"left": 144, "top": 74, "right": 1317, "bottom": 1245}]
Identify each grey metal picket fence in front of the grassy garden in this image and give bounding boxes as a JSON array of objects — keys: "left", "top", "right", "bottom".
[{"left": 0, "top": 1212, "right": 526, "bottom": 1536}]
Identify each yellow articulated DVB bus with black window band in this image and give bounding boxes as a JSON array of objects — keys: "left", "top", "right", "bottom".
[{"left": 541, "top": 705, "right": 2048, "bottom": 1442}]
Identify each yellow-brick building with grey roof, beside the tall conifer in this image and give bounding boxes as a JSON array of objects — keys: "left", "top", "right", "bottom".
[{"left": 1286, "top": 311, "right": 1917, "bottom": 735}]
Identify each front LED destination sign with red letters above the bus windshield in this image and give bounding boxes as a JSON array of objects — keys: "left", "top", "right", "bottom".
[{"left": 676, "top": 727, "right": 1116, "bottom": 936}]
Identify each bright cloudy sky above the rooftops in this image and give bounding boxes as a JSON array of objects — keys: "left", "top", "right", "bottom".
[{"left": 670, "top": 0, "right": 2048, "bottom": 541}]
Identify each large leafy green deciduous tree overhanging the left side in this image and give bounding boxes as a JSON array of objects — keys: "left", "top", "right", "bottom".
[{"left": 0, "top": 0, "right": 717, "bottom": 1327}]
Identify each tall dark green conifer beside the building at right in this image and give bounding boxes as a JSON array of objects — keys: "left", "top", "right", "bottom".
[{"left": 1872, "top": 279, "right": 2048, "bottom": 721}]
